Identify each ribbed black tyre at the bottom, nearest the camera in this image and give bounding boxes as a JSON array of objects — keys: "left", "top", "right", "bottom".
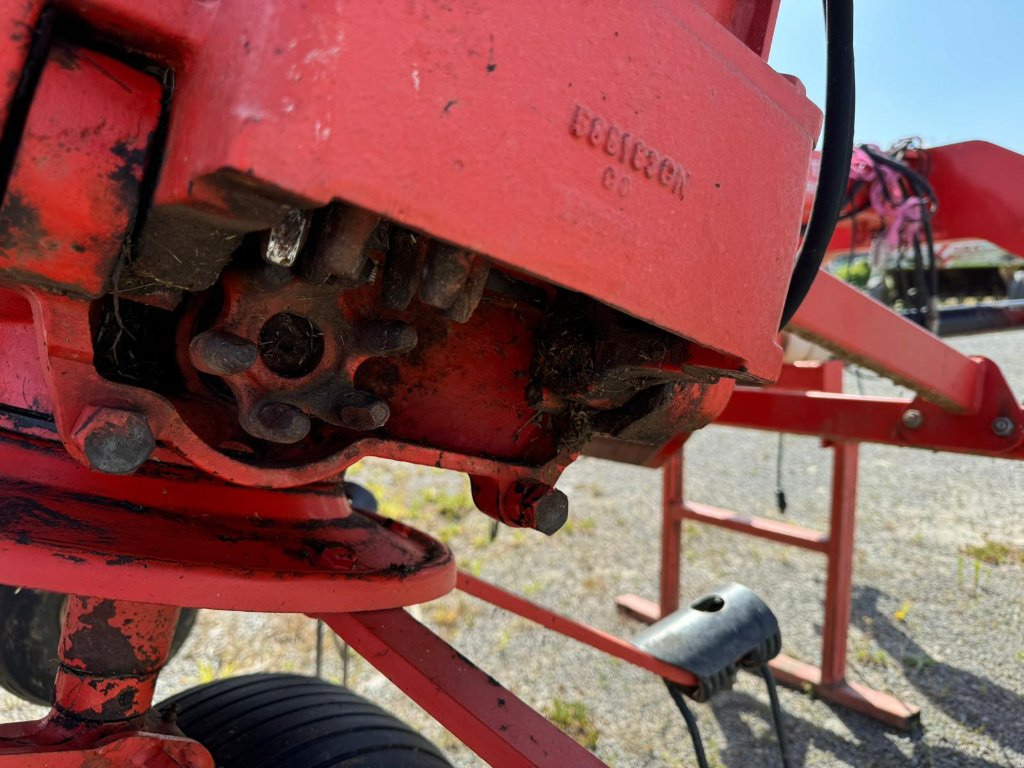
[{"left": 158, "top": 674, "right": 451, "bottom": 768}]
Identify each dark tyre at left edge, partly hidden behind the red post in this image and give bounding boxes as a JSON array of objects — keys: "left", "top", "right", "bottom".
[{"left": 0, "top": 586, "right": 196, "bottom": 706}]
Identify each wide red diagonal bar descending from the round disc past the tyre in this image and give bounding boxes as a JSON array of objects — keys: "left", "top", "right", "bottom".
[{"left": 319, "top": 609, "right": 604, "bottom": 768}]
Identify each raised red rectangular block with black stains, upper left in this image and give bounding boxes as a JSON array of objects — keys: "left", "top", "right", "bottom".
[{"left": 0, "top": 44, "right": 163, "bottom": 297}]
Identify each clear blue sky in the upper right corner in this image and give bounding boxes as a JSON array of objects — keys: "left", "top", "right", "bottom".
[{"left": 769, "top": 0, "right": 1024, "bottom": 155}]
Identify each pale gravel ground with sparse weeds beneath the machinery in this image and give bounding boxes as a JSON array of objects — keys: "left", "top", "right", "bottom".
[{"left": 0, "top": 332, "right": 1024, "bottom": 768}]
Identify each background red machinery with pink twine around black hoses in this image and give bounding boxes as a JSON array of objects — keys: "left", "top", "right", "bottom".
[{"left": 819, "top": 138, "right": 1024, "bottom": 336}]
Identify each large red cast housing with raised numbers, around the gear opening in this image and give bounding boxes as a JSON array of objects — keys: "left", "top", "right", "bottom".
[{"left": 0, "top": 0, "right": 802, "bottom": 495}]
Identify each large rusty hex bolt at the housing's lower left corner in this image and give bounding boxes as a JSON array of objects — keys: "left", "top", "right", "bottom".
[{"left": 73, "top": 408, "right": 157, "bottom": 475}]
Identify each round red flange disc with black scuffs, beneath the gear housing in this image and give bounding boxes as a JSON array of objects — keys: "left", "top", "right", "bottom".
[{"left": 0, "top": 433, "right": 455, "bottom": 612}]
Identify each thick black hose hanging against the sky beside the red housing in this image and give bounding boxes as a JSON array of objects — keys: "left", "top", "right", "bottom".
[{"left": 779, "top": 0, "right": 856, "bottom": 329}]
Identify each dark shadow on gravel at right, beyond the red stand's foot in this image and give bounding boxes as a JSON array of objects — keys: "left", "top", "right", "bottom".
[{"left": 853, "top": 587, "right": 1024, "bottom": 765}]
